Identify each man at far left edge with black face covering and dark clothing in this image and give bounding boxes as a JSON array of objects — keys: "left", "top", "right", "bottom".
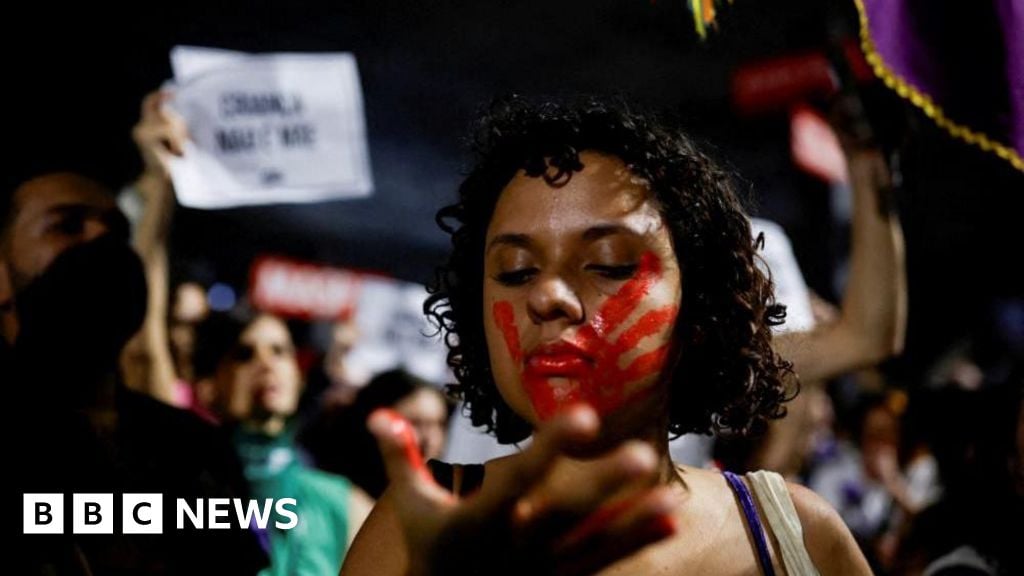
[{"left": 0, "top": 163, "right": 266, "bottom": 574}]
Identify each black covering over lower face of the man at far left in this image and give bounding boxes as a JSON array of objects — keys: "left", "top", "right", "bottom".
[{"left": 13, "top": 236, "right": 147, "bottom": 377}]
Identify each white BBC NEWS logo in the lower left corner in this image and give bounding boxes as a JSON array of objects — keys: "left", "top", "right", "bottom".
[{"left": 22, "top": 494, "right": 299, "bottom": 534}]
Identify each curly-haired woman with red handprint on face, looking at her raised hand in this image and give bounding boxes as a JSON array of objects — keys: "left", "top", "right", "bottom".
[{"left": 342, "top": 98, "right": 868, "bottom": 575}]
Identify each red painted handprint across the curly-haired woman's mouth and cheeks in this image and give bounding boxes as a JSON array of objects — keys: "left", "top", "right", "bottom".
[{"left": 493, "top": 252, "right": 679, "bottom": 420}]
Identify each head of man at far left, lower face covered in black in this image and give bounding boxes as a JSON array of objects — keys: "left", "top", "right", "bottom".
[{"left": 0, "top": 167, "right": 136, "bottom": 401}]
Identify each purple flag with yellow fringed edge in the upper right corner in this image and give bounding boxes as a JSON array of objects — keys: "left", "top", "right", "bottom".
[{"left": 854, "top": 0, "right": 1024, "bottom": 171}]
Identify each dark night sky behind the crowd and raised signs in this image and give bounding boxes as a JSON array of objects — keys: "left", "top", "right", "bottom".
[{"left": 0, "top": 0, "right": 1024, "bottom": 383}]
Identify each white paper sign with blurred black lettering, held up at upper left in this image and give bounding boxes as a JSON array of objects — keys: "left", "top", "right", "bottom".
[{"left": 165, "top": 47, "right": 373, "bottom": 208}]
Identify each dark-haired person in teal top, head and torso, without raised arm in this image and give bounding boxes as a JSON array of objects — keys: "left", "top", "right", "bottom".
[{"left": 195, "top": 308, "right": 373, "bottom": 575}]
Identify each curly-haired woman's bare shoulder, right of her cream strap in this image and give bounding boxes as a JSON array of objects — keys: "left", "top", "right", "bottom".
[{"left": 787, "top": 483, "right": 871, "bottom": 575}]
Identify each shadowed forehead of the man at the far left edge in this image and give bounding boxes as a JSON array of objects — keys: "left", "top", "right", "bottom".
[{"left": 13, "top": 172, "right": 115, "bottom": 221}]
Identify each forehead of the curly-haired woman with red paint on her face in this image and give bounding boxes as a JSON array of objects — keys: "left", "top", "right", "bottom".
[{"left": 487, "top": 152, "right": 662, "bottom": 237}]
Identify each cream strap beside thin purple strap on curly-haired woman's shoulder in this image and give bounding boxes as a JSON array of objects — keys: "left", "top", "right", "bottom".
[{"left": 746, "top": 470, "right": 818, "bottom": 576}]
